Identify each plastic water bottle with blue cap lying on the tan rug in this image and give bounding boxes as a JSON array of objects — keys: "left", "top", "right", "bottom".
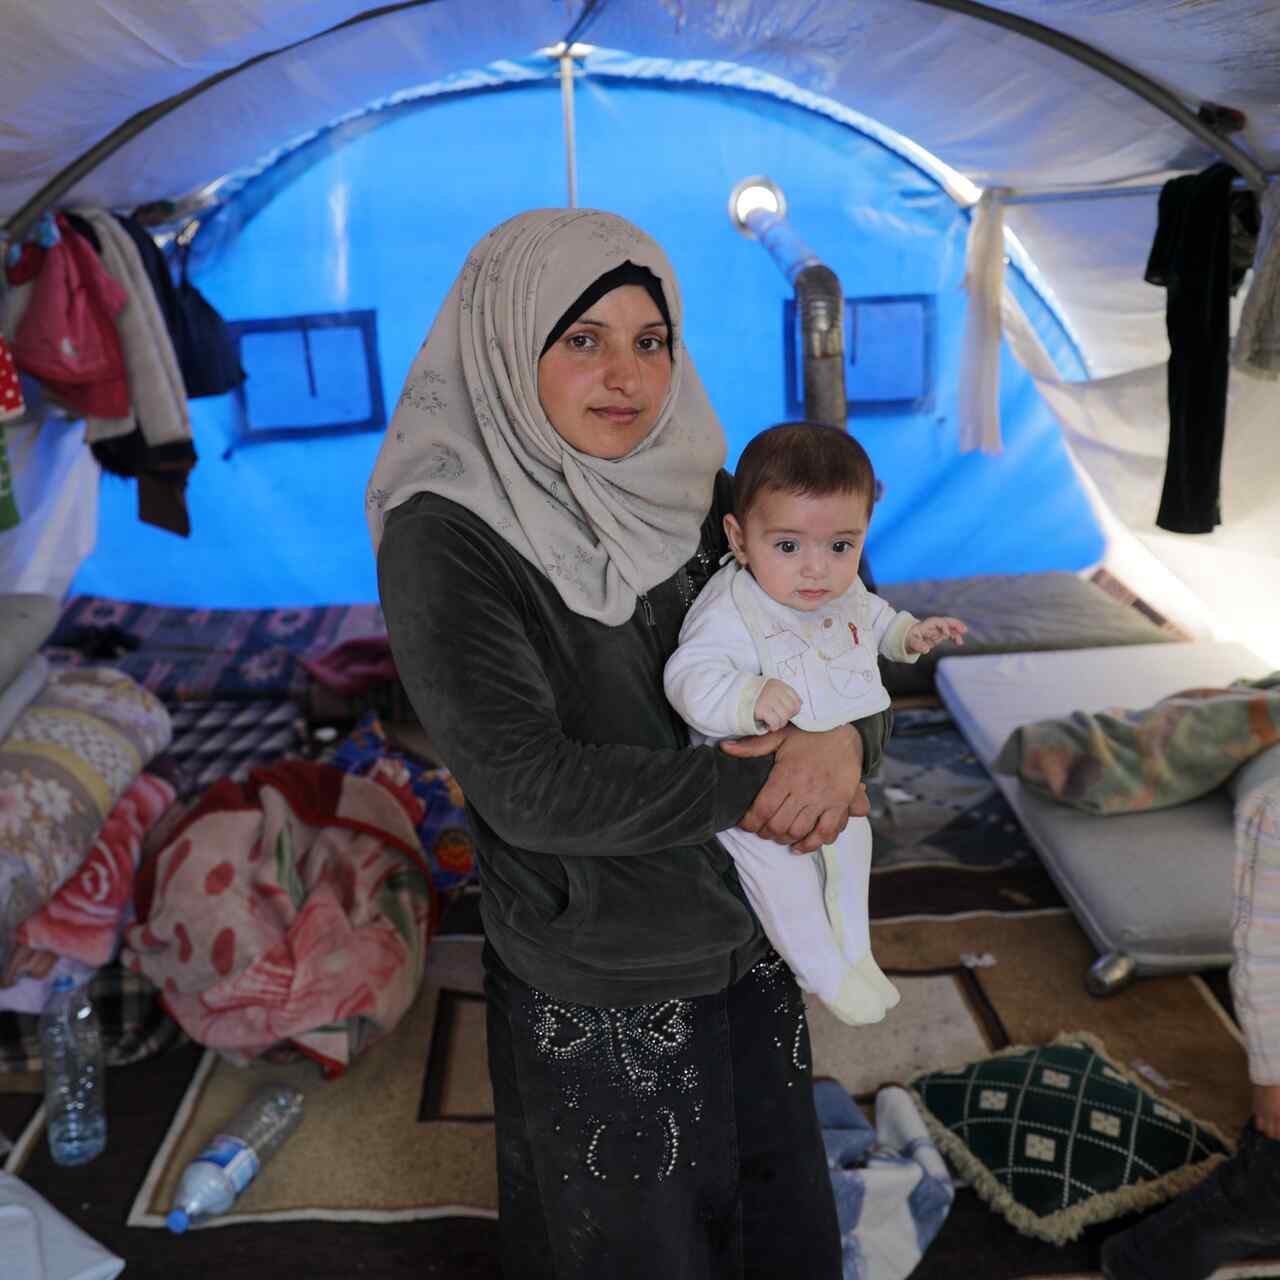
[{"left": 165, "top": 1084, "right": 302, "bottom": 1233}]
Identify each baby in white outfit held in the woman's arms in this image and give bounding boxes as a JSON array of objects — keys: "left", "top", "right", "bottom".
[{"left": 664, "top": 422, "right": 966, "bottom": 1024}]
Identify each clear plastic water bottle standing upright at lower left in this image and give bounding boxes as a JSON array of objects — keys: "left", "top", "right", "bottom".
[{"left": 40, "top": 975, "right": 106, "bottom": 1165}]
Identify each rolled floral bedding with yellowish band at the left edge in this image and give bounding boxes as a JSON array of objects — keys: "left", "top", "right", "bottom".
[{"left": 0, "top": 667, "right": 172, "bottom": 938}]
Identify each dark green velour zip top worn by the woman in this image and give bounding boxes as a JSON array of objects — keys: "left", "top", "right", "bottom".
[{"left": 378, "top": 472, "right": 891, "bottom": 1006}]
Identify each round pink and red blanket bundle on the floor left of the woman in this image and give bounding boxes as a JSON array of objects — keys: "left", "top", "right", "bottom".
[{"left": 123, "top": 760, "right": 434, "bottom": 1075}]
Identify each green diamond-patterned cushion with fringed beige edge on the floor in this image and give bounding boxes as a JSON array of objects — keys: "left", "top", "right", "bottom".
[{"left": 911, "top": 1032, "right": 1231, "bottom": 1244}]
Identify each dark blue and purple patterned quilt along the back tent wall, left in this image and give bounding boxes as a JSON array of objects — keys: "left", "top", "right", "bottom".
[{"left": 45, "top": 595, "right": 387, "bottom": 703}]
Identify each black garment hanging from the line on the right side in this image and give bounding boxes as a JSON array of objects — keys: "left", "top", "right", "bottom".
[{"left": 1146, "top": 164, "right": 1258, "bottom": 534}]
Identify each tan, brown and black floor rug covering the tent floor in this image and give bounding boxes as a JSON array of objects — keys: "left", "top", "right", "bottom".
[{"left": 5, "top": 931, "right": 1280, "bottom": 1280}]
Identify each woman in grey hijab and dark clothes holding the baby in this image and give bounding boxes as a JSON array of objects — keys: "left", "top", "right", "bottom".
[{"left": 367, "top": 210, "right": 888, "bottom": 1280}]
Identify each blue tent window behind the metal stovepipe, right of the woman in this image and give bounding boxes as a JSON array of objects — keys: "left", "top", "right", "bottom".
[{"left": 782, "top": 293, "right": 936, "bottom": 417}]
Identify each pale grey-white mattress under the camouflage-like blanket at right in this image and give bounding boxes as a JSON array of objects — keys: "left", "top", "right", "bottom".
[{"left": 937, "top": 641, "right": 1268, "bottom": 973}]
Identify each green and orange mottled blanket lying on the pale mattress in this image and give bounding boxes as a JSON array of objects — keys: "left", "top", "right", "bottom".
[{"left": 992, "top": 672, "right": 1280, "bottom": 814}]
